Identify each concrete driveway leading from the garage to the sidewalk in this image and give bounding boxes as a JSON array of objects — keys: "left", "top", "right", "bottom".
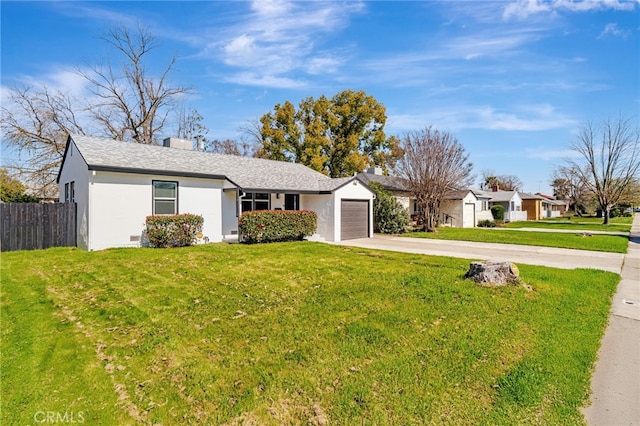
[{"left": 335, "top": 235, "right": 624, "bottom": 274}]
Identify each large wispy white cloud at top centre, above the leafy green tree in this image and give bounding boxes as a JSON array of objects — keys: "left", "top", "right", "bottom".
[{"left": 209, "top": 0, "right": 363, "bottom": 87}]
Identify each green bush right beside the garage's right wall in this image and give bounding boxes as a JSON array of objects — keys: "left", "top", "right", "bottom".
[{"left": 367, "top": 182, "right": 409, "bottom": 234}]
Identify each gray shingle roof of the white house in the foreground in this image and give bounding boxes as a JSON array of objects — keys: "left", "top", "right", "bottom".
[{"left": 70, "top": 135, "right": 362, "bottom": 192}]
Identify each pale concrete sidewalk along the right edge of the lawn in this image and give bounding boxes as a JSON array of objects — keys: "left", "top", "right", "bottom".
[{"left": 582, "top": 214, "right": 640, "bottom": 426}]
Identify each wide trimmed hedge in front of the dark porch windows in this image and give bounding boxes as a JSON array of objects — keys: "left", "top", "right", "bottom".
[{"left": 238, "top": 210, "right": 318, "bottom": 243}]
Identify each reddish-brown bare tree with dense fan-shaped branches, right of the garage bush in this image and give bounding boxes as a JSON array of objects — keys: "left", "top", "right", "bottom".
[{"left": 394, "top": 126, "right": 473, "bottom": 231}]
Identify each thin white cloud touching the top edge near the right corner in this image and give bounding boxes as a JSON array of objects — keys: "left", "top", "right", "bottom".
[{"left": 502, "top": 0, "right": 638, "bottom": 20}]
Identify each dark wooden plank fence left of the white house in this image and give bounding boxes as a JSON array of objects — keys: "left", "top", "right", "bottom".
[{"left": 0, "top": 203, "right": 76, "bottom": 251}]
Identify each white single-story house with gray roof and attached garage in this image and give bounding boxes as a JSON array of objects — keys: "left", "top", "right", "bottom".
[{"left": 57, "top": 135, "right": 374, "bottom": 250}]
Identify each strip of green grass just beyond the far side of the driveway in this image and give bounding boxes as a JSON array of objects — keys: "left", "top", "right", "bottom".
[{"left": 400, "top": 228, "right": 629, "bottom": 253}]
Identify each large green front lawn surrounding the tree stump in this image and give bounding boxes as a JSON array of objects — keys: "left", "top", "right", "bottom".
[{"left": 0, "top": 242, "right": 619, "bottom": 425}]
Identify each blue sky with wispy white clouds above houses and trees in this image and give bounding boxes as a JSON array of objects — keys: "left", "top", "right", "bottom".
[{"left": 0, "top": 0, "right": 640, "bottom": 193}]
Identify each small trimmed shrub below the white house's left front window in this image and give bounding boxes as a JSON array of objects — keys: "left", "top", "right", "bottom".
[{"left": 146, "top": 213, "right": 204, "bottom": 247}]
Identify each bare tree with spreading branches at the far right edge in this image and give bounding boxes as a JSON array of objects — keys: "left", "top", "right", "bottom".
[{"left": 567, "top": 117, "right": 640, "bottom": 225}]
